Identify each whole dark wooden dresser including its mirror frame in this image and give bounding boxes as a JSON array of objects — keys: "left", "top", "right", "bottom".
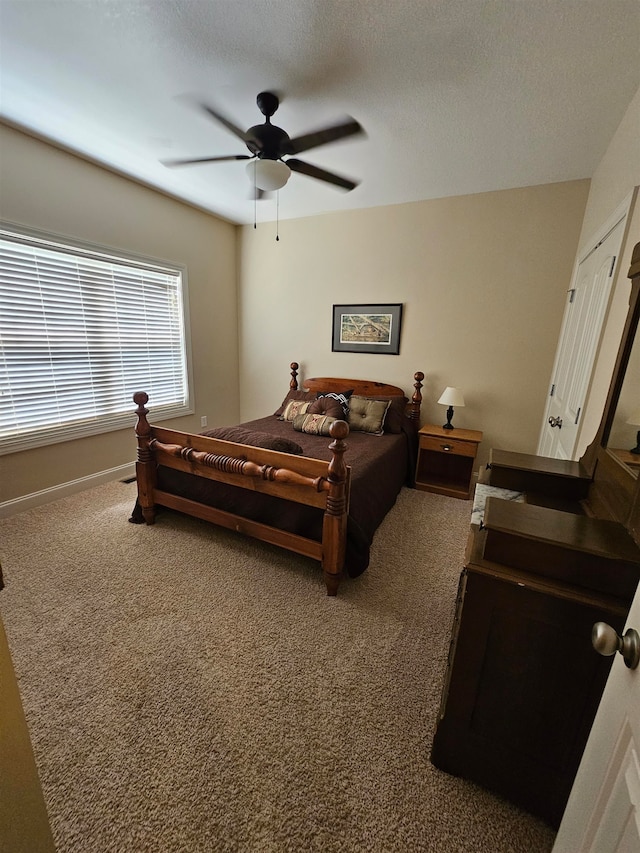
[{"left": 431, "top": 244, "right": 640, "bottom": 827}]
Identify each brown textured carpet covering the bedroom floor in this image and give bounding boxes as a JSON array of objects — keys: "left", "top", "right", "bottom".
[{"left": 0, "top": 482, "right": 555, "bottom": 853}]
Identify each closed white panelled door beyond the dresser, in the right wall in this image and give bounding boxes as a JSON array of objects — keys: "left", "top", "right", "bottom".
[{"left": 538, "top": 212, "right": 626, "bottom": 459}]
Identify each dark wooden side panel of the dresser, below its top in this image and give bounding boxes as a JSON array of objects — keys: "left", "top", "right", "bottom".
[{"left": 431, "top": 567, "right": 624, "bottom": 826}]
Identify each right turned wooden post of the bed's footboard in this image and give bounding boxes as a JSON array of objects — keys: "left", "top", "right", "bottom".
[{"left": 322, "top": 421, "right": 349, "bottom": 595}]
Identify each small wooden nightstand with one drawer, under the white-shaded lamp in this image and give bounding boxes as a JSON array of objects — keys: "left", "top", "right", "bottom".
[{"left": 416, "top": 424, "right": 482, "bottom": 500}]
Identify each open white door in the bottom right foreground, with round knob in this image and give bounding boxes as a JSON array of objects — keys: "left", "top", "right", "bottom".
[{"left": 552, "top": 586, "right": 640, "bottom": 853}]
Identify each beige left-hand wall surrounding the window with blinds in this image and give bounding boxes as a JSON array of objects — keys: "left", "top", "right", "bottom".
[{"left": 0, "top": 125, "right": 239, "bottom": 501}]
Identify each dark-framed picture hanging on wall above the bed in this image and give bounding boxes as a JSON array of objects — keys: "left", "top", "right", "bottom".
[{"left": 331, "top": 303, "right": 402, "bottom": 355}]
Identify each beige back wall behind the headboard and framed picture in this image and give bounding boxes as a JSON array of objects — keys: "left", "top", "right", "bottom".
[{"left": 240, "top": 181, "right": 589, "bottom": 461}]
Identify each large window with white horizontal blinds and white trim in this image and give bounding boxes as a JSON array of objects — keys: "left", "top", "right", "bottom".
[{"left": 0, "top": 225, "right": 193, "bottom": 453}]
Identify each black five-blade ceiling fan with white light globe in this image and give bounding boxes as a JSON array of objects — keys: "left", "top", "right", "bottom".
[{"left": 162, "top": 92, "right": 364, "bottom": 198}]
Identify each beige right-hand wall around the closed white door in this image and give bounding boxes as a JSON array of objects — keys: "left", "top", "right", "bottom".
[{"left": 577, "top": 89, "right": 640, "bottom": 455}]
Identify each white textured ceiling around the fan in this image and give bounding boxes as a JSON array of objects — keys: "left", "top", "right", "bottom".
[{"left": 0, "top": 0, "right": 640, "bottom": 223}]
